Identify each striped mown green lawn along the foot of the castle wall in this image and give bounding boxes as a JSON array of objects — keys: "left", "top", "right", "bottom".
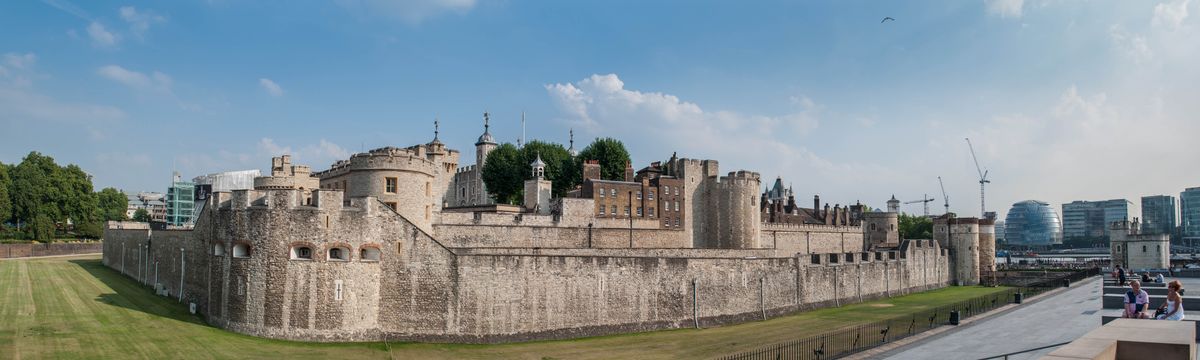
[{"left": 0, "top": 256, "right": 1003, "bottom": 359}]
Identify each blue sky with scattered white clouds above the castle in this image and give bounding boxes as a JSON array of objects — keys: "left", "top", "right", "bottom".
[{"left": 0, "top": 0, "right": 1200, "bottom": 215}]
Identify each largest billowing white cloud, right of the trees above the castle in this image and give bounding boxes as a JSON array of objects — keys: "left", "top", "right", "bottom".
[{"left": 545, "top": 74, "right": 913, "bottom": 204}]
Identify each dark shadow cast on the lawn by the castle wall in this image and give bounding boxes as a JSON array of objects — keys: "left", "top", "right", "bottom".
[{"left": 68, "top": 259, "right": 208, "bottom": 326}]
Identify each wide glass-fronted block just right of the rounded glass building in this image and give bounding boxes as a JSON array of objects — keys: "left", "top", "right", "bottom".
[{"left": 1062, "top": 199, "right": 1133, "bottom": 241}]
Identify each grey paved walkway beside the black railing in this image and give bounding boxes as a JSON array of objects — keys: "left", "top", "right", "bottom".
[{"left": 881, "top": 277, "right": 1100, "bottom": 360}]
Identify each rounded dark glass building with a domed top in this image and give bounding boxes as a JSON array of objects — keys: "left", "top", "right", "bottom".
[{"left": 1004, "top": 200, "right": 1062, "bottom": 245}]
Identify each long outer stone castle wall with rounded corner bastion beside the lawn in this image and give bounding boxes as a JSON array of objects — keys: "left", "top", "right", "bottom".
[{"left": 104, "top": 191, "right": 949, "bottom": 342}]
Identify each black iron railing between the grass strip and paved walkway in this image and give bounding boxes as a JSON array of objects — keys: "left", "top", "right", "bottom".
[{"left": 718, "top": 269, "right": 1100, "bottom": 360}]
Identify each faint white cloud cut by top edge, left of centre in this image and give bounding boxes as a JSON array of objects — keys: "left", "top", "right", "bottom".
[{"left": 336, "top": 0, "right": 475, "bottom": 25}]
